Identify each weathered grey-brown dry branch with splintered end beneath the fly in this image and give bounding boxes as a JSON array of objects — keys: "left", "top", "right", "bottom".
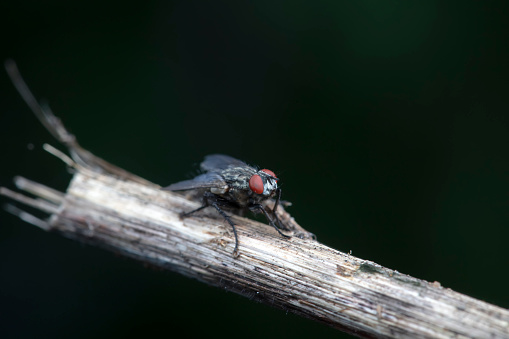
[{"left": 0, "top": 64, "right": 509, "bottom": 338}]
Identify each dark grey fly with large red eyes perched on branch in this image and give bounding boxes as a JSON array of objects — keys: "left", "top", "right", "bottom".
[{"left": 163, "top": 154, "right": 291, "bottom": 255}]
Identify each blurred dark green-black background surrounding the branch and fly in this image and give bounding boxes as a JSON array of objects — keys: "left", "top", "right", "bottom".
[{"left": 0, "top": 1, "right": 509, "bottom": 338}]
